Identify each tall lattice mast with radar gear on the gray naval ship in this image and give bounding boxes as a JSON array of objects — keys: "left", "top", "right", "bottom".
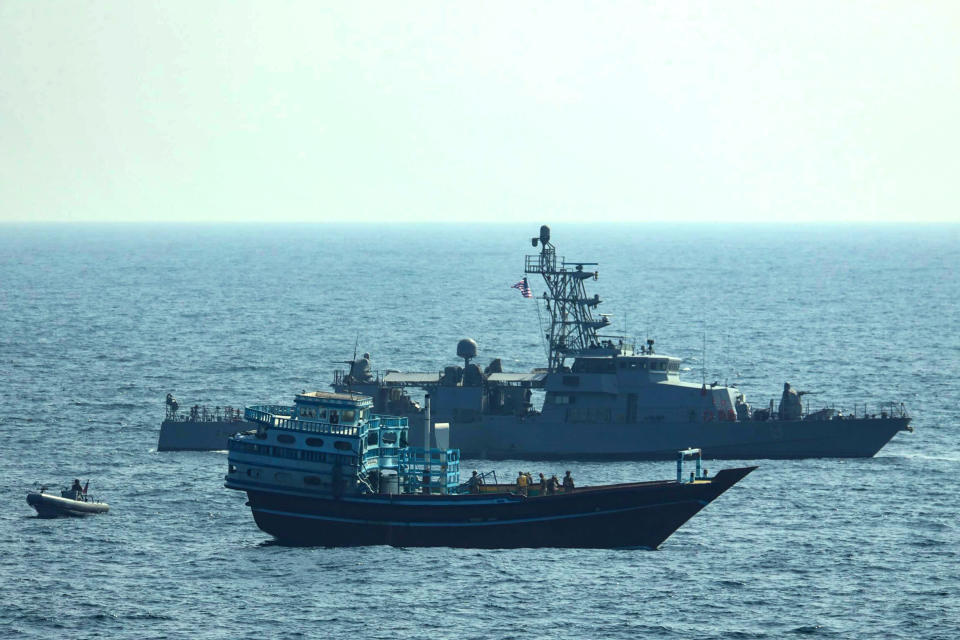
[{"left": 524, "top": 225, "right": 619, "bottom": 372}]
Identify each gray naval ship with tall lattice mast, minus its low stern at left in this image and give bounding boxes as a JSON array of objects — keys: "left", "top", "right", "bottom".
[{"left": 332, "top": 226, "right": 912, "bottom": 460}]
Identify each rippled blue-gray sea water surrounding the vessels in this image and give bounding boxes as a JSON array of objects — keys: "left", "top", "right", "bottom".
[{"left": 0, "top": 224, "right": 960, "bottom": 640}]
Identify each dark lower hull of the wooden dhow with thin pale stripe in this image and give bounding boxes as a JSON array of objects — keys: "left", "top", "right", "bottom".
[{"left": 247, "top": 468, "right": 755, "bottom": 549}]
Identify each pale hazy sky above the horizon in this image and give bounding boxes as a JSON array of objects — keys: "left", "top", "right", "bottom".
[{"left": 0, "top": 0, "right": 960, "bottom": 224}]
